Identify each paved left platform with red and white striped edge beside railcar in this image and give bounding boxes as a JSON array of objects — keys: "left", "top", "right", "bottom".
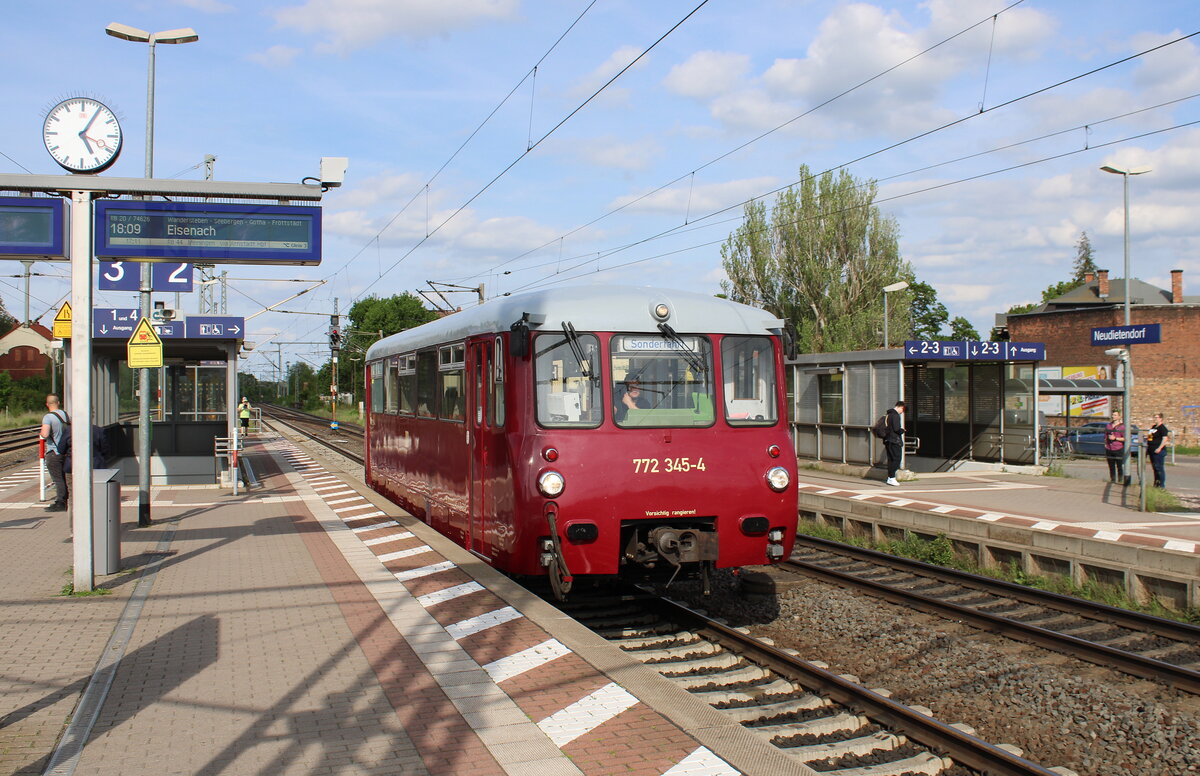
[{"left": 0, "top": 434, "right": 811, "bottom": 776}]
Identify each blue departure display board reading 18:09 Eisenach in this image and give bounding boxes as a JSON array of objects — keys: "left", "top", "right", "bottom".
[{"left": 96, "top": 200, "right": 320, "bottom": 265}]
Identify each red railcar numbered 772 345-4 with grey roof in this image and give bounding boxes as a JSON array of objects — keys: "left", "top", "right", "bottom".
[{"left": 366, "top": 287, "right": 797, "bottom": 595}]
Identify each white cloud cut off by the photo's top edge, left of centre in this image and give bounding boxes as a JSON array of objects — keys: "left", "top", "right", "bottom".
[{"left": 275, "top": 0, "right": 520, "bottom": 54}]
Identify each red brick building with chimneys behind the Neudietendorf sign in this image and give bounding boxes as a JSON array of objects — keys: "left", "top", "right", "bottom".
[{"left": 997, "top": 270, "right": 1200, "bottom": 445}]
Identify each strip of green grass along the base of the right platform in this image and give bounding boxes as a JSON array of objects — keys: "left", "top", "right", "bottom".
[{"left": 797, "top": 522, "right": 1200, "bottom": 624}]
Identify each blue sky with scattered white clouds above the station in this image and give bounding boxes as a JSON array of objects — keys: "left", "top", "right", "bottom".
[{"left": 0, "top": 0, "right": 1200, "bottom": 378}]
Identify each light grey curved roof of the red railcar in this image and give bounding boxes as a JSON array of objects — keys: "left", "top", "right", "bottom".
[{"left": 367, "top": 285, "right": 784, "bottom": 361}]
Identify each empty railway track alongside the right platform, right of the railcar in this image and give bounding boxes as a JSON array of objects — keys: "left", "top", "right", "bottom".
[{"left": 780, "top": 535, "right": 1200, "bottom": 693}]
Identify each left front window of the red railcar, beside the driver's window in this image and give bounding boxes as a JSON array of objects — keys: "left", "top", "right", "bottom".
[{"left": 535, "top": 333, "right": 604, "bottom": 428}]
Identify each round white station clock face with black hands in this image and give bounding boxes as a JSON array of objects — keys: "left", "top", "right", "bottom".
[{"left": 42, "top": 97, "right": 121, "bottom": 173}]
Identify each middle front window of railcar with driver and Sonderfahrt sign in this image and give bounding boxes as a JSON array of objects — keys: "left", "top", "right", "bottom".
[{"left": 611, "top": 335, "right": 715, "bottom": 428}]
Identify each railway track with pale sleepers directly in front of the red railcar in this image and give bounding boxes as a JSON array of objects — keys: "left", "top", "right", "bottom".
[{"left": 558, "top": 594, "right": 1058, "bottom": 776}]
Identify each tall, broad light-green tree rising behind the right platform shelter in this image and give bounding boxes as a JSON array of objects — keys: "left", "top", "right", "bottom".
[{"left": 721, "top": 166, "right": 913, "bottom": 353}]
